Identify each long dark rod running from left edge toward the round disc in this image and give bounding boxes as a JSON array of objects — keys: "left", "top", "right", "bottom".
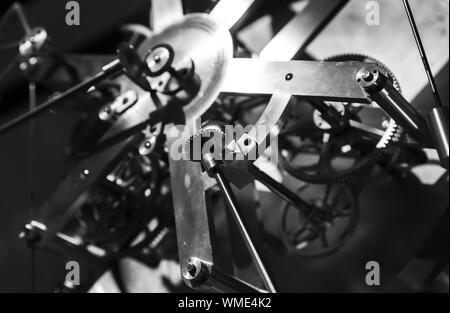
[{"left": 0, "top": 60, "right": 122, "bottom": 134}]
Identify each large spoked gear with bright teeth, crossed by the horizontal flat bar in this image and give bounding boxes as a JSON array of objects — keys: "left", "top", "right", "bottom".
[{"left": 279, "top": 54, "right": 402, "bottom": 184}]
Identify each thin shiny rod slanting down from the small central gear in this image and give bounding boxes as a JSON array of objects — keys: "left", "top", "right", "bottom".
[{"left": 213, "top": 169, "right": 276, "bottom": 293}]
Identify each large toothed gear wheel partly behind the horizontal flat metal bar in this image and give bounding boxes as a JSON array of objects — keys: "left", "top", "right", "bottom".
[{"left": 279, "top": 54, "right": 402, "bottom": 184}]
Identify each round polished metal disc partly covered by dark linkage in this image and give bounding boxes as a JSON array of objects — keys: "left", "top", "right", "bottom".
[{"left": 139, "top": 14, "right": 233, "bottom": 120}]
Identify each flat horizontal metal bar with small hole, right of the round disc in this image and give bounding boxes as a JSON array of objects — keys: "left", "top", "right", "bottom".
[{"left": 221, "top": 59, "right": 369, "bottom": 103}]
